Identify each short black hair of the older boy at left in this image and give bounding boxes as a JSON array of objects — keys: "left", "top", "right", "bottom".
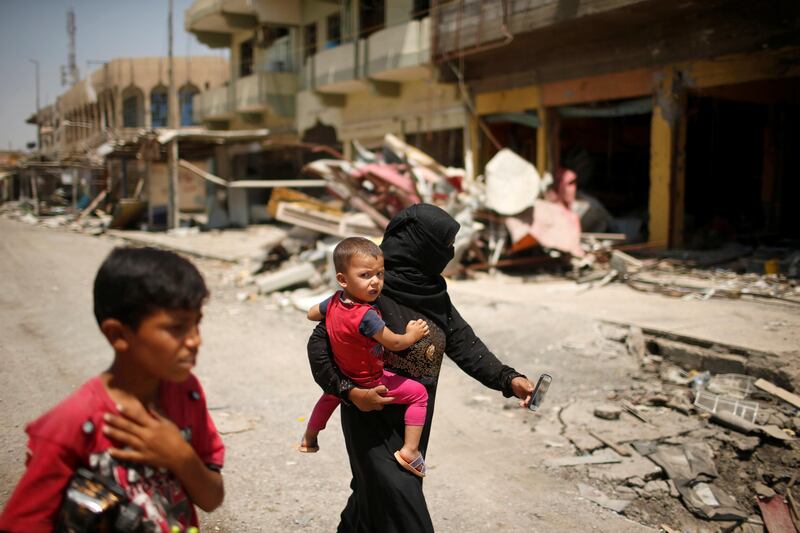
[{"left": 94, "top": 247, "right": 208, "bottom": 329}]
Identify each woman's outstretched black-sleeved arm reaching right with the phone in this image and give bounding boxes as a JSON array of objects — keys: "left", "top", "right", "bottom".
[{"left": 445, "top": 305, "right": 533, "bottom": 402}]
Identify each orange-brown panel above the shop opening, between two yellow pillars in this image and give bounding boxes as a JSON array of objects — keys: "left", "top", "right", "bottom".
[{"left": 542, "top": 68, "right": 655, "bottom": 106}]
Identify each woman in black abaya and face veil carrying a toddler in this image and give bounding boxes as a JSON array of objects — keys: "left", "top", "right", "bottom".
[{"left": 308, "top": 204, "right": 533, "bottom": 533}]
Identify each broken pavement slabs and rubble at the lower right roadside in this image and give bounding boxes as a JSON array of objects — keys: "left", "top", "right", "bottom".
[{"left": 533, "top": 328, "right": 800, "bottom": 532}]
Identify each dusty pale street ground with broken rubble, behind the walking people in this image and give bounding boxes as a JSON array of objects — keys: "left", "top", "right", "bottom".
[{"left": 0, "top": 193, "right": 800, "bottom": 531}]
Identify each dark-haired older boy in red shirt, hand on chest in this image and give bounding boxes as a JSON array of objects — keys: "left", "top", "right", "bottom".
[{"left": 0, "top": 248, "right": 225, "bottom": 533}]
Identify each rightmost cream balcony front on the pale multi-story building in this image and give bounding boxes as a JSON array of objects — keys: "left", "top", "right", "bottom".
[{"left": 366, "top": 17, "right": 431, "bottom": 82}]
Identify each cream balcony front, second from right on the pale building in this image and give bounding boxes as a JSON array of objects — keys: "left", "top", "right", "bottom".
[{"left": 304, "top": 39, "right": 369, "bottom": 94}]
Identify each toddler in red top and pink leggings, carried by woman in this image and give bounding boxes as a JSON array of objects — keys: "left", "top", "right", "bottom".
[{"left": 299, "top": 237, "right": 428, "bottom": 477}]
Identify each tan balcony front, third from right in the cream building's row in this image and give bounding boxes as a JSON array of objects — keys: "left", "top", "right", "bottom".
[{"left": 236, "top": 72, "right": 297, "bottom": 117}]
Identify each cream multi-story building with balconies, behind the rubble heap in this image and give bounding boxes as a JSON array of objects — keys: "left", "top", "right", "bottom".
[{"left": 185, "top": 0, "right": 467, "bottom": 165}]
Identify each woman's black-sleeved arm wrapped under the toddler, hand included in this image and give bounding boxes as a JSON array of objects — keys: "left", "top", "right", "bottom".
[{"left": 307, "top": 321, "right": 394, "bottom": 411}]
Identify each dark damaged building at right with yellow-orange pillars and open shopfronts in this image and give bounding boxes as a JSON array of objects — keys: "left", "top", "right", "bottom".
[{"left": 432, "top": 0, "right": 800, "bottom": 246}]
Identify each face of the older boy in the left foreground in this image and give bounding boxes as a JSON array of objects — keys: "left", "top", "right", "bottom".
[{"left": 128, "top": 309, "right": 203, "bottom": 383}]
